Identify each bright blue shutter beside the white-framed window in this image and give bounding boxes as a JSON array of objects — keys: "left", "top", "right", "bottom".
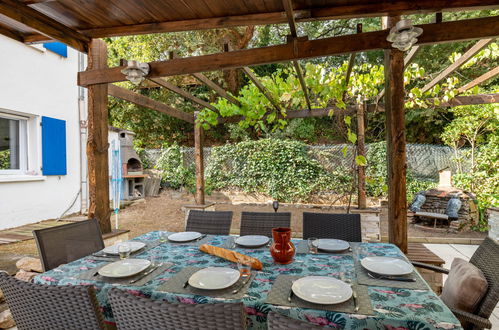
[{"left": 42, "top": 117, "right": 67, "bottom": 175}]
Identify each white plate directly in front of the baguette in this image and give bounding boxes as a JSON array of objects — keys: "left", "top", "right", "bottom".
[{"left": 189, "top": 267, "right": 239, "bottom": 290}]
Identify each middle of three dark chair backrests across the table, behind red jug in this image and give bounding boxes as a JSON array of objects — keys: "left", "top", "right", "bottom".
[{"left": 239, "top": 212, "right": 291, "bottom": 237}]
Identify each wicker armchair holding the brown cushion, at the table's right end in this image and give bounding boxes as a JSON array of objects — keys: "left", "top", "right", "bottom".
[{"left": 412, "top": 237, "right": 499, "bottom": 330}]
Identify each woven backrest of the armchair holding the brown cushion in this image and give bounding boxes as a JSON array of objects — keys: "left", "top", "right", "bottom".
[{"left": 470, "top": 237, "right": 499, "bottom": 319}]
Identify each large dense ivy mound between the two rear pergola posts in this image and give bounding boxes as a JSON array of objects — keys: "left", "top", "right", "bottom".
[{"left": 206, "top": 139, "right": 333, "bottom": 202}]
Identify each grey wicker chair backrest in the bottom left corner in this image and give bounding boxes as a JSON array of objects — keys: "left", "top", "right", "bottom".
[{"left": 0, "top": 272, "right": 104, "bottom": 330}]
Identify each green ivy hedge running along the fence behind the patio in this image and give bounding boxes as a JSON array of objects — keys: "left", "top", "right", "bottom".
[{"left": 156, "top": 139, "right": 436, "bottom": 202}]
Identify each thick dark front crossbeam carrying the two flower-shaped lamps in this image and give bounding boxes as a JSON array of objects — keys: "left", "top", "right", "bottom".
[{"left": 78, "top": 16, "right": 499, "bottom": 86}]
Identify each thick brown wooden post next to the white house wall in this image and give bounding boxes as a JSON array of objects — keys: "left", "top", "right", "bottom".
[{"left": 87, "top": 39, "right": 111, "bottom": 234}]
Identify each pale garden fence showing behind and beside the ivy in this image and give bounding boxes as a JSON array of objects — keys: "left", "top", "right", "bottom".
[{"left": 146, "top": 144, "right": 469, "bottom": 180}]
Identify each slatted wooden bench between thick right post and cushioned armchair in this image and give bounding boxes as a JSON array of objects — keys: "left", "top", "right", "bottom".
[{"left": 407, "top": 243, "right": 445, "bottom": 294}]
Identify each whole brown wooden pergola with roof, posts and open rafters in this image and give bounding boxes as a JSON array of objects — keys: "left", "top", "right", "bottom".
[{"left": 0, "top": 0, "right": 499, "bottom": 252}]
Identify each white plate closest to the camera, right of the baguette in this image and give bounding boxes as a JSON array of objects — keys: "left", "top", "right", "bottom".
[{"left": 291, "top": 276, "right": 352, "bottom": 305}]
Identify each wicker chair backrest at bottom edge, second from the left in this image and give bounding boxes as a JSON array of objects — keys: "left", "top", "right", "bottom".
[{"left": 108, "top": 288, "right": 246, "bottom": 330}]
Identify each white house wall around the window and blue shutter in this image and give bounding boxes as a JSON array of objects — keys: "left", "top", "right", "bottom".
[{"left": 0, "top": 35, "right": 81, "bottom": 229}]
